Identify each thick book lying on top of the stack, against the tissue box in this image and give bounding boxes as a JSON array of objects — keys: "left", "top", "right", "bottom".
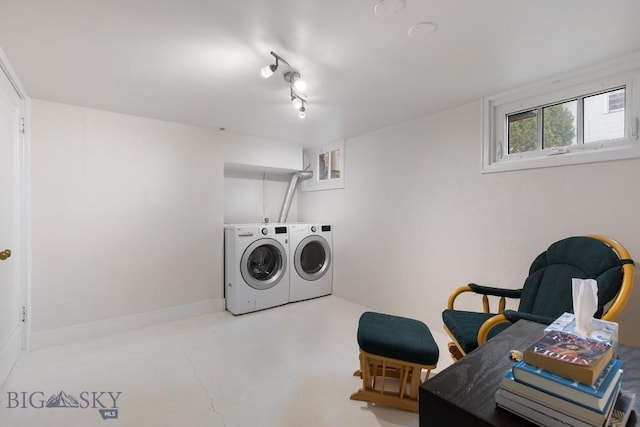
[{"left": 523, "top": 331, "right": 613, "bottom": 385}]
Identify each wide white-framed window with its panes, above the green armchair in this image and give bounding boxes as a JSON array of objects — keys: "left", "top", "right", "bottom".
[{"left": 482, "top": 55, "right": 640, "bottom": 173}]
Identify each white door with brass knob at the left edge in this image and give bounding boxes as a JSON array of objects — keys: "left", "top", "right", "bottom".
[{"left": 0, "top": 64, "right": 24, "bottom": 384}]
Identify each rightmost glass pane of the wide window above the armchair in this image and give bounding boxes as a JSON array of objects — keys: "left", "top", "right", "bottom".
[{"left": 584, "top": 88, "right": 625, "bottom": 144}]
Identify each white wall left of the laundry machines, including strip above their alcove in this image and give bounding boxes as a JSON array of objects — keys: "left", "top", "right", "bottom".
[{"left": 31, "top": 100, "right": 302, "bottom": 340}]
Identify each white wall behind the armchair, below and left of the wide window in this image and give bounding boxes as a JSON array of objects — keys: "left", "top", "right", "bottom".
[{"left": 298, "top": 102, "right": 640, "bottom": 346}]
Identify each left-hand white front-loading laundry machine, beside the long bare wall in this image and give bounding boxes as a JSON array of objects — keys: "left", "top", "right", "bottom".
[{"left": 224, "top": 224, "right": 289, "bottom": 314}]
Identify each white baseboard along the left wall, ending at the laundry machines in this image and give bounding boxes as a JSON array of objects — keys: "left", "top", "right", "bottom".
[{"left": 29, "top": 299, "right": 225, "bottom": 350}]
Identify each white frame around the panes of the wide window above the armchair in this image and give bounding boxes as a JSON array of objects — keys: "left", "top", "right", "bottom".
[{"left": 482, "top": 53, "right": 640, "bottom": 173}]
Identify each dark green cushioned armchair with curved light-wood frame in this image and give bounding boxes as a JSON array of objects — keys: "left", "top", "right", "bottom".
[{"left": 442, "top": 235, "right": 634, "bottom": 360}]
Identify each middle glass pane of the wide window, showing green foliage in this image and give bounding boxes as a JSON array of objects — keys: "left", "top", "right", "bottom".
[{"left": 542, "top": 100, "right": 578, "bottom": 149}]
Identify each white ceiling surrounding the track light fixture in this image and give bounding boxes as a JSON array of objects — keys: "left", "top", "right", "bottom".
[{"left": 0, "top": 0, "right": 640, "bottom": 146}]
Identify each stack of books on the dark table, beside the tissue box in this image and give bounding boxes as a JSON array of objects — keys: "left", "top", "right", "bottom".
[{"left": 495, "top": 317, "right": 635, "bottom": 427}]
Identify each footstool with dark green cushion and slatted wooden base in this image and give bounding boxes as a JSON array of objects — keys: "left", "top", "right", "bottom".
[{"left": 351, "top": 311, "right": 440, "bottom": 412}]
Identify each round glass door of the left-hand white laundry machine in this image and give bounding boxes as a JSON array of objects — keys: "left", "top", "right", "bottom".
[{"left": 240, "top": 239, "right": 287, "bottom": 290}]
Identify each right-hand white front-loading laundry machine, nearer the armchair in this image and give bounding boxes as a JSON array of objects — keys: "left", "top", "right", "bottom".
[{"left": 289, "top": 224, "right": 333, "bottom": 302}]
